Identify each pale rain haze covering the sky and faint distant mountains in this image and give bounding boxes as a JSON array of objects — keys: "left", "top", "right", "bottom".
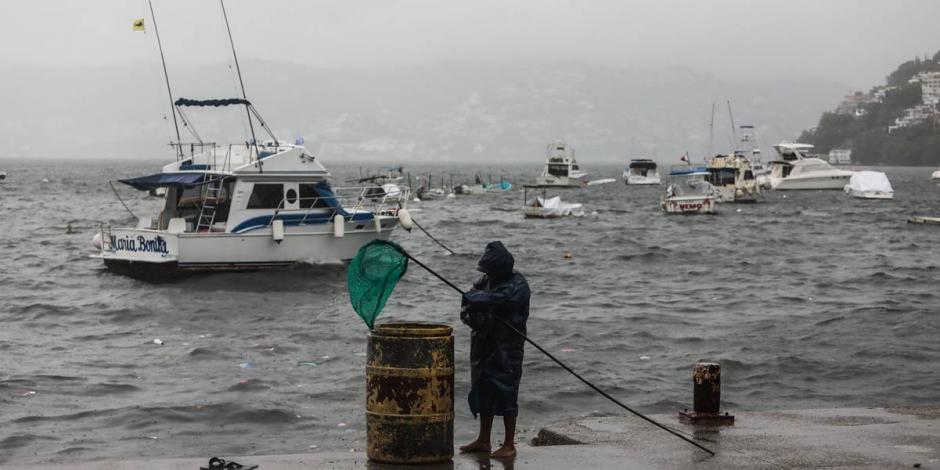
[{"left": 0, "top": 0, "right": 940, "bottom": 162}]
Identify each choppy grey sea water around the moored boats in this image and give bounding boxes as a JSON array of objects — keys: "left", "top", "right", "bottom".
[{"left": 0, "top": 160, "right": 940, "bottom": 463}]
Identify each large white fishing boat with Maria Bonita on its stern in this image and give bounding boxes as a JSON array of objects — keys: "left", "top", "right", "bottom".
[{"left": 93, "top": 99, "right": 408, "bottom": 276}]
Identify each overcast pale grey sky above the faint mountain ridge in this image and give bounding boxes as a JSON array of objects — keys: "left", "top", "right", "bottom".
[{"left": 0, "top": 0, "right": 940, "bottom": 89}]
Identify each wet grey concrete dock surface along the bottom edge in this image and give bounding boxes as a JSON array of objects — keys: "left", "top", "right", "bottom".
[{"left": 0, "top": 406, "right": 940, "bottom": 470}]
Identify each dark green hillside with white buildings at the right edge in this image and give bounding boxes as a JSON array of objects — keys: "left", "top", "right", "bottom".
[{"left": 799, "top": 52, "right": 940, "bottom": 166}]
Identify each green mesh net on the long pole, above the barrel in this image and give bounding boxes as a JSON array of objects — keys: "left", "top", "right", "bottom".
[{"left": 346, "top": 240, "right": 408, "bottom": 330}]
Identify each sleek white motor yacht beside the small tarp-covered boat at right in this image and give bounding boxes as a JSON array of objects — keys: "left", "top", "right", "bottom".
[{"left": 767, "top": 144, "right": 855, "bottom": 191}]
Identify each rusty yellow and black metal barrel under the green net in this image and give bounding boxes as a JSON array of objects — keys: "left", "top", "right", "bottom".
[{"left": 366, "top": 323, "right": 454, "bottom": 464}]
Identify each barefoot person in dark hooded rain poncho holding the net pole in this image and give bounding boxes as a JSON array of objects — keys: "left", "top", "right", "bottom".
[{"left": 460, "top": 241, "right": 530, "bottom": 458}]
